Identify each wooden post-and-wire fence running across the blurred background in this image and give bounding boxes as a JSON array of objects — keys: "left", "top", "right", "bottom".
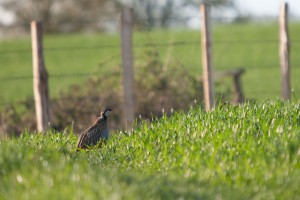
[{"left": 0, "top": 4, "right": 297, "bottom": 133}]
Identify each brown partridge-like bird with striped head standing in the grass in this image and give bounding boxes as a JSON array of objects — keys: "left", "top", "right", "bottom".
[{"left": 77, "top": 107, "right": 112, "bottom": 151}]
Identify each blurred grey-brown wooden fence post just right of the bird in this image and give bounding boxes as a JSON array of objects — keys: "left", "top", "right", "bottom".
[{"left": 121, "top": 7, "right": 134, "bottom": 128}]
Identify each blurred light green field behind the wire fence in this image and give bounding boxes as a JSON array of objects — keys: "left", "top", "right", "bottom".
[{"left": 0, "top": 23, "right": 300, "bottom": 103}]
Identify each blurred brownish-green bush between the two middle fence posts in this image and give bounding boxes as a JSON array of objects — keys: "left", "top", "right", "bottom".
[{"left": 136, "top": 49, "right": 203, "bottom": 118}]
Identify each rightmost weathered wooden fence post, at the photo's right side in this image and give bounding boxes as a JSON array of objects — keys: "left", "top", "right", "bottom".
[{"left": 279, "top": 0, "right": 291, "bottom": 100}]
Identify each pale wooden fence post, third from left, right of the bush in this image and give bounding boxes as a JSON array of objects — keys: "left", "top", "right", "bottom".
[{"left": 200, "top": 4, "right": 215, "bottom": 111}]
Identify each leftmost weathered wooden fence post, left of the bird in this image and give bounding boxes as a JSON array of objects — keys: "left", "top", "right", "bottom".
[{"left": 31, "top": 21, "right": 50, "bottom": 131}]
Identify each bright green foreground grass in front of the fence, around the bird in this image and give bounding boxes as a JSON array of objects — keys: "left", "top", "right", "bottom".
[{"left": 0, "top": 101, "right": 300, "bottom": 199}]
